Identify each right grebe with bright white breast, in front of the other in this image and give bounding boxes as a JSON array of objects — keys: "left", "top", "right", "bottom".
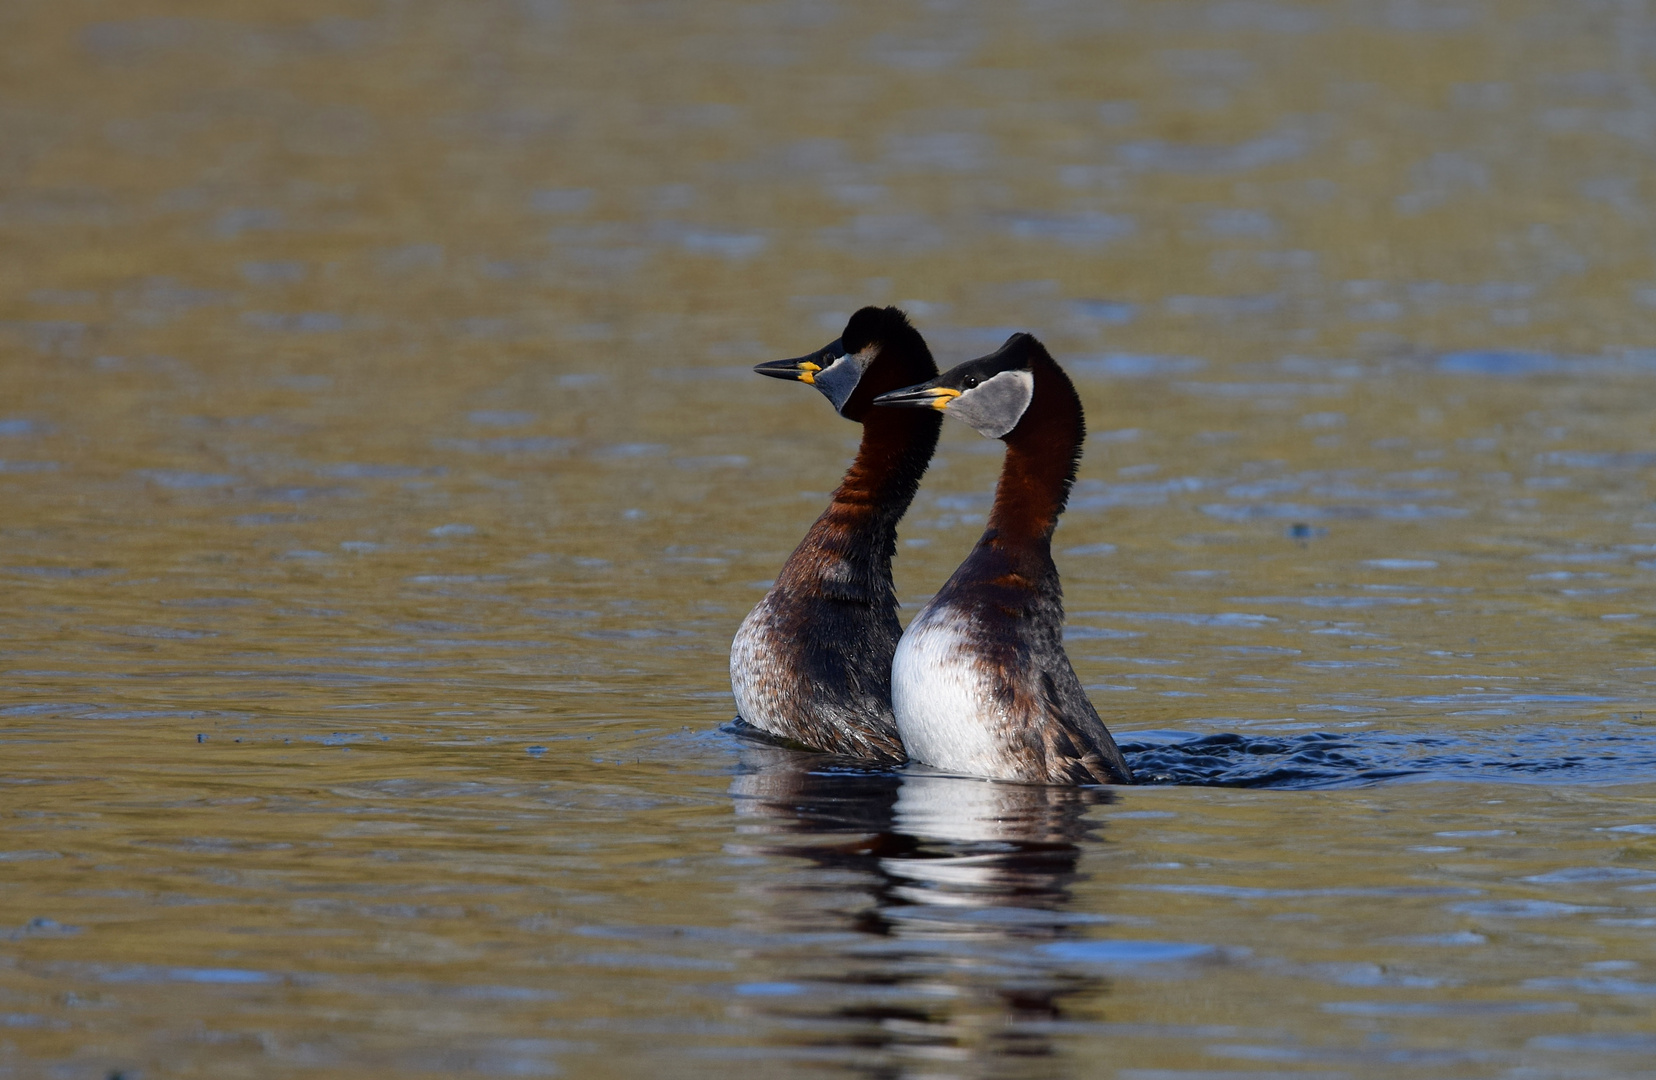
[{"left": 874, "top": 333, "right": 1133, "bottom": 783}]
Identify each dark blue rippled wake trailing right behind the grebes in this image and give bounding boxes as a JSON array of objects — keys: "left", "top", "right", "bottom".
[{"left": 1118, "top": 722, "right": 1656, "bottom": 790}]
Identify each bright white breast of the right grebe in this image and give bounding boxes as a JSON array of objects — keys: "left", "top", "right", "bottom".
[{"left": 891, "top": 606, "right": 1010, "bottom": 777}]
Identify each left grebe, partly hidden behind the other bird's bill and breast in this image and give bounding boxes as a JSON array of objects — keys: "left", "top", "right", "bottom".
[{"left": 730, "top": 308, "right": 942, "bottom": 762}]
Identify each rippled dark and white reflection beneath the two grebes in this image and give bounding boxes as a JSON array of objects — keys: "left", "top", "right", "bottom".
[{"left": 730, "top": 747, "right": 1110, "bottom": 1077}]
